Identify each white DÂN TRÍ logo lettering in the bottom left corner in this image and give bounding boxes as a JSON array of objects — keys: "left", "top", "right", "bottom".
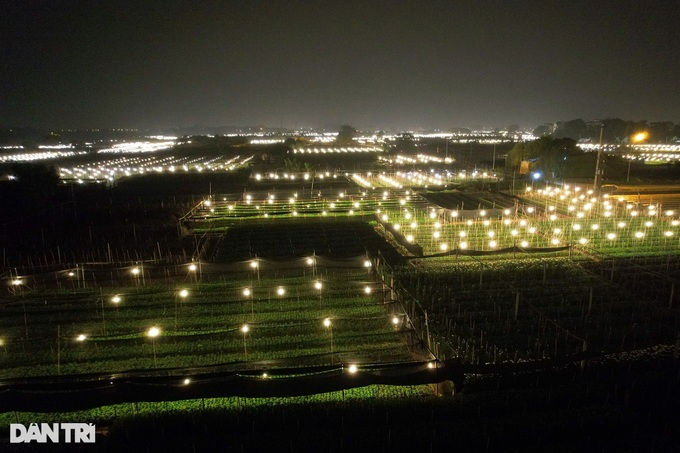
[{"left": 9, "top": 423, "right": 95, "bottom": 444}]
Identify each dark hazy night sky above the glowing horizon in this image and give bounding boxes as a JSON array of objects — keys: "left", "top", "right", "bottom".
[{"left": 0, "top": 0, "right": 680, "bottom": 130}]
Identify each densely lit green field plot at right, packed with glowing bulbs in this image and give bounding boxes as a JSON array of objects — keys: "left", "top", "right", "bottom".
[{"left": 372, "top": 183, "right": 680, "bottom": 257}]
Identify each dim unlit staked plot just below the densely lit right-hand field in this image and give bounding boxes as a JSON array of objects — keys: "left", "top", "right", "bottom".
[{"left": 395, "top": 259, "right": 680, "bottom": 364}]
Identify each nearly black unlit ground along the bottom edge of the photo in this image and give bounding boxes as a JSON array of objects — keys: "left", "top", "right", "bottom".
[{"left": 2, "top": 351, "right": 680, "bottom": 452}]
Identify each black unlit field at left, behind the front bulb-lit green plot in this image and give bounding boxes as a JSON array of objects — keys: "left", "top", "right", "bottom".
[{"left": 0, "top": 172, "right": 260, "bottom": 273}]
